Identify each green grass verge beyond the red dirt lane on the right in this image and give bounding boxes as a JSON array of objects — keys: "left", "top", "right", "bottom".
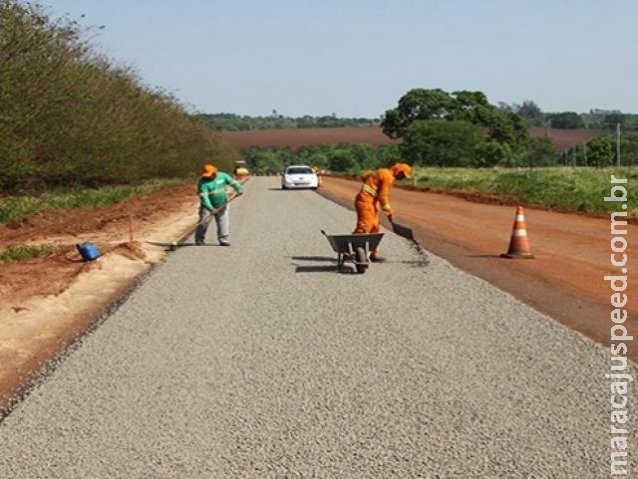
[{"left": 415, "top": 167, "right": 638, "bottom": 216}]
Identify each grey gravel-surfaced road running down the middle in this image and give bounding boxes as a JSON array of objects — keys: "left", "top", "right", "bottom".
[{"left": 0, "top": 178, "right": 638, "bottom": 479}]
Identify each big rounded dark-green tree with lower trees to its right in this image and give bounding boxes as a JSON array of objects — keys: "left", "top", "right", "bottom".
[{"left": 381, "top": 88, "right": 638, "bottom": 168}]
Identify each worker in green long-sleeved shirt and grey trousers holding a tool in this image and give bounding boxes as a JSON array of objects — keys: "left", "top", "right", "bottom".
[{"left": 195, "top": 165, "right": 242, "bottom": 246}]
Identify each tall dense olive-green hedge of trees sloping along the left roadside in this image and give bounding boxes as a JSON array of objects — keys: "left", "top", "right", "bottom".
[{"left": 0, "top": 0, "right": 240, "bottom": 194}]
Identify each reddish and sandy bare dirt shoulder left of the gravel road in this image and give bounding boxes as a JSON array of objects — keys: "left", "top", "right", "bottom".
[{"left": 0, "top": 186, "right": 198, "bottom": 418}]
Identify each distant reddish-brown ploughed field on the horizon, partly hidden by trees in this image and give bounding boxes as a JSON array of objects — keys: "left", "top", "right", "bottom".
[{"left": 220, "top": 127, "right": 600, "bottom": 151}]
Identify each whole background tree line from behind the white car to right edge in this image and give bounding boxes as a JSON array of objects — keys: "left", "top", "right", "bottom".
[{"left": 242, "top": 88, "right": 638, "bottom": 174}]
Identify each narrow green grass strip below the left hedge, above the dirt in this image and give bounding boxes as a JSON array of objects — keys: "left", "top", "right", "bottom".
[{"left": 0, "top": 180, "right": 184, "bottom": 224}]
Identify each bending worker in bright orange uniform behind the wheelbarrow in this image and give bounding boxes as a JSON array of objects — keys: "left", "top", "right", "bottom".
[{"left": 354, "top": 163, "right": 412, "bottom": 261}]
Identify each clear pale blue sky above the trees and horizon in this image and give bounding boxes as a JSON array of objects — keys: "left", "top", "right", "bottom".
[{"left": 42, "top": 0, "right": 638, "bottom": 118}]
